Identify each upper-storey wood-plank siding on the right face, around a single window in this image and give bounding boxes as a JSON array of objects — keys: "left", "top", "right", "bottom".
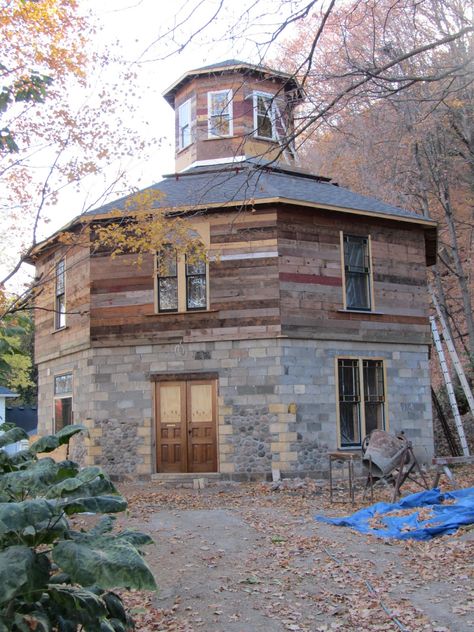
[{"left": 278, "top": 209, "right": 429, "bottom": 344}]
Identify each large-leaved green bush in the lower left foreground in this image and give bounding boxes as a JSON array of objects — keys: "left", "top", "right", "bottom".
[{"left": 0, "top": 424, "right": 156, "bottom": 632}]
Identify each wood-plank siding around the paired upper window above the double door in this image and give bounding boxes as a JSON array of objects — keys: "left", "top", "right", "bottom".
[{"left": 91, "top": 211, "right": 280, "bottom": 346}]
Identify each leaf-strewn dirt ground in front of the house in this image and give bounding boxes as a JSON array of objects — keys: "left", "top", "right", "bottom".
[{"left": 115, "top": 471, "right": 474, "bottom": 632}]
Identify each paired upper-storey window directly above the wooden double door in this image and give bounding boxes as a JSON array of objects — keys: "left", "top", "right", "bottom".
[{"left": 155, "top": 245, "right": 208, "bottom": 314}]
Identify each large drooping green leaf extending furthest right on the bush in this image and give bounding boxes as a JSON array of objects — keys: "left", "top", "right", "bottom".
[{"left": 53, "top": 535, "right": 156, "bottom": 590}]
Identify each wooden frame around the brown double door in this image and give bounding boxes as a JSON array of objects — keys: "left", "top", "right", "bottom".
[{"left": 150, "top": 371, "right": 220, "bottom": 474}]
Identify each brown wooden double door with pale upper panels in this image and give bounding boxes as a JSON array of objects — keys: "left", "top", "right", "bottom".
[{"left": 155, "top": 380, "right": 217, "bottom": 473}]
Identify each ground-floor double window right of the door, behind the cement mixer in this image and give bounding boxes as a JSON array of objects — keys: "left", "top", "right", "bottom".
[{"left": 337, "top": 358, "right": 385, "bottom": 448}]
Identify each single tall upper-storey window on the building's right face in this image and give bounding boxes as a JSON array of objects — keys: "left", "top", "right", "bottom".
[{"left": 343, "top": 235, "right": 372, "bottom": 311}]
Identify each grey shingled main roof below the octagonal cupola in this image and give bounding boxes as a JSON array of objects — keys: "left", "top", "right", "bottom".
[{"left": 89, "top": 161, "right": 435, "bottom": 225}]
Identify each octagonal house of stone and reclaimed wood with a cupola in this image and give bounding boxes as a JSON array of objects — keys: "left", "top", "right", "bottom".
[{"left": 30, "top": 60, "right": 436, "bottom": 479}]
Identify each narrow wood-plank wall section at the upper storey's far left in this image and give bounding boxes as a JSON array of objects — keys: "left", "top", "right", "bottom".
[{"left": 35, "top": 239, "right": 90, "bottom": 363}]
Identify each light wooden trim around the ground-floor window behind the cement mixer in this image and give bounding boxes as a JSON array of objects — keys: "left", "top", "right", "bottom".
[{"left": 334, "top": 354, "right": 390, "bottom": 451}]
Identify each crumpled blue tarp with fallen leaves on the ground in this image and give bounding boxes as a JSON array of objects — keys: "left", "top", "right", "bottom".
[{"left": 315, "top": 487, "right": 474, "bottom": 540}]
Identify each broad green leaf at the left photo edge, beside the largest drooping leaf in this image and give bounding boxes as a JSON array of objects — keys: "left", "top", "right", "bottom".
[{"left": 0, "top": 546, "right": 50, "bottom": 604}]
